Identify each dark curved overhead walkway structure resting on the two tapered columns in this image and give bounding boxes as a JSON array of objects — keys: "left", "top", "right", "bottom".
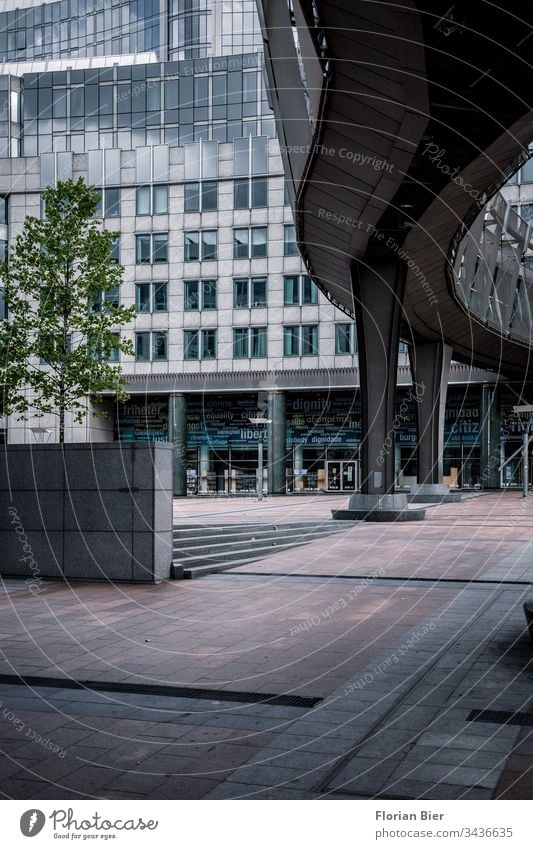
[{"left": 262, "top": 0, "right": 533, "bottom": 375}]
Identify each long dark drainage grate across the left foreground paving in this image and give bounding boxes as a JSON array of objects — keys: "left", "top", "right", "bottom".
[{"left": 0, "top": 675, "right": 322, "bottom": 708}]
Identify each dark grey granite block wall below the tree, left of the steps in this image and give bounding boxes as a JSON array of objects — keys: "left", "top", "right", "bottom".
[{"left": 0, "top": 443, "right": 173, "bottom": 583}]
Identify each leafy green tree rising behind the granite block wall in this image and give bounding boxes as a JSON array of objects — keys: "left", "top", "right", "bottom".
[{"left": 0, "top": 178, "right": 135, "bottom": 442}]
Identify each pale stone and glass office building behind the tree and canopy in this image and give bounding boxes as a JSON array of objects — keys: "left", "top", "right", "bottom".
[{"left": 0, "top": 0, "right": 516, "bottom": 494}]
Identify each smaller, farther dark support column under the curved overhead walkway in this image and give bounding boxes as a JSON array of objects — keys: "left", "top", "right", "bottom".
[{"left": 409, "top": 341, "right": 452, "bottom": 486}]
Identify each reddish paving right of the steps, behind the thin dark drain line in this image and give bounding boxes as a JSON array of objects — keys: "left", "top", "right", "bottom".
[{"left": 229, "top": 492, "right": 533, "bottom": 581}]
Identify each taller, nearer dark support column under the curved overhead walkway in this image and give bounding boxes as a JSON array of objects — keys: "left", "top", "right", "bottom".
[{"left": 352, "top": 260, "right": 406, "bottom": 495}]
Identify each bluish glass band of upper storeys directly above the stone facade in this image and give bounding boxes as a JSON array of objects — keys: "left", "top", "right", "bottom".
[{"left": 19, "top": 54, "right": 274, "bottom": 157}]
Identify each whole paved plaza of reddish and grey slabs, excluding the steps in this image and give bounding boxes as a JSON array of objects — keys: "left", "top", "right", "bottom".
[{"left": 0, "top": 492, "right": 533, "bottom": 800}]
